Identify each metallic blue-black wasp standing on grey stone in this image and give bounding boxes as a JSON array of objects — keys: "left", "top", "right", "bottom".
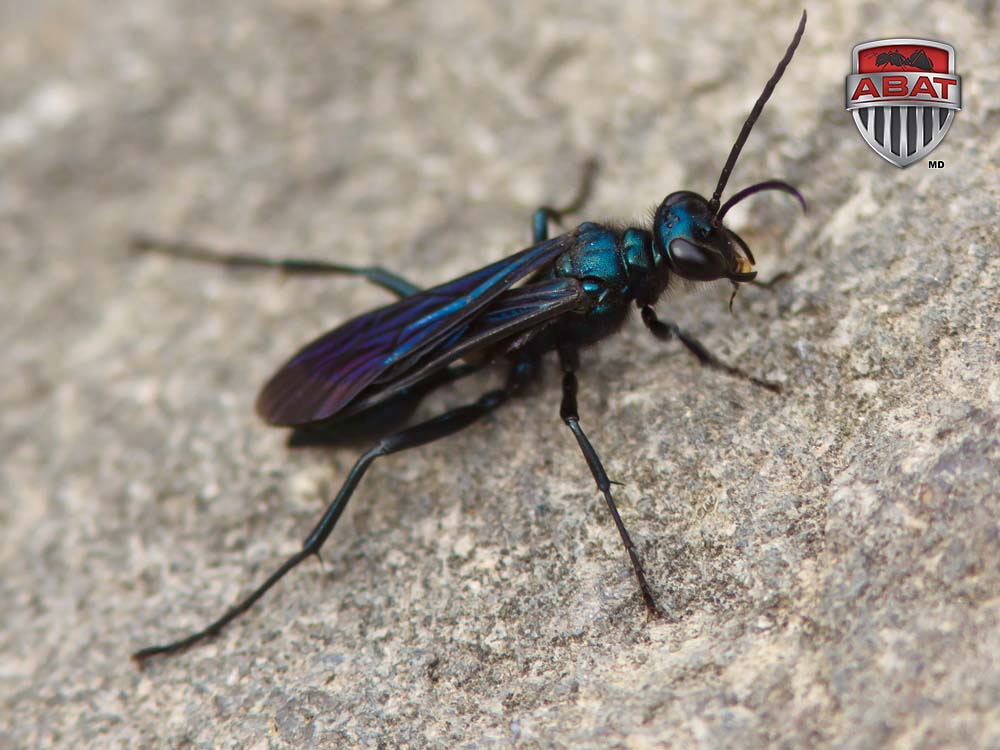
[{"left": 133, "top": 12, "right": 806, "bottom": 663}]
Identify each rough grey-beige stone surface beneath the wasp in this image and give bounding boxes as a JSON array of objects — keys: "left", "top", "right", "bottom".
[{"left": 0, "top": 0, "right": 1000, "bottom": 749}]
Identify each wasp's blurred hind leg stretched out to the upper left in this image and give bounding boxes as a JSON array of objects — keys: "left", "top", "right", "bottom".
[{"left": 129, "top": 233, "right": 420, "bottom": 297}]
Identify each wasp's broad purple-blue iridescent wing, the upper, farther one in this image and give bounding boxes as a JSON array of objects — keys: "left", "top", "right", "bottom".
[{"left": 257, "top": 235, "right": 572, "bottom": 427}]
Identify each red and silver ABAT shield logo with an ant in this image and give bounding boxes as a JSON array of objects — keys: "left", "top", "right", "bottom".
[{"left": 847, "top": 39, "right": 962, "bottom": 167}]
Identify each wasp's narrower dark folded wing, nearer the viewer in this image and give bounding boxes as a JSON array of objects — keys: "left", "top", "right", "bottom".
[{"left": 344, "top": 279, "right": 584, "bottom": 415}]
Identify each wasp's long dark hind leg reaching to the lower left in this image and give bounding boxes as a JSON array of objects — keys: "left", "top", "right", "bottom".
[{"left": 132, "top": 360, "right": 537, "bottom": 666}]
